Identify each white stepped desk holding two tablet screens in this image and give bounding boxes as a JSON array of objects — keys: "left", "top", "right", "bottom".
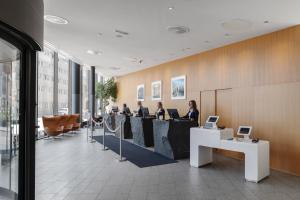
[{"left": 190, "top": 128, "right": 270, "bottom": 182}]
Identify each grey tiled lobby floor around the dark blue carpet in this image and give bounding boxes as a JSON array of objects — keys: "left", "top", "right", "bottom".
[{"left": 36, "top": 131, "right": 300, "bottom": 200}]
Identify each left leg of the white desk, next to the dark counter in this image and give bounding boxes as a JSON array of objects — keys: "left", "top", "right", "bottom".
[{"left": 190, "top": 146, "right": 213, "bottom": 167}]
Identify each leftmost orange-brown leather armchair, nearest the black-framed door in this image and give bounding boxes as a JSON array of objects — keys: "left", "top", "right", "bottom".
[{"left": 42, "top": 116, "right": 64, "bottom": 137}]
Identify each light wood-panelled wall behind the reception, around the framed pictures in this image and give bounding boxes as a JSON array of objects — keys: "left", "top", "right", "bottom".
[{"left": 117, "top": 26, "right": 300, "bottom": 175}]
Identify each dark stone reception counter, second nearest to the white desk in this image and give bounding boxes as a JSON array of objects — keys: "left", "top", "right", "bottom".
[{"left": 130, "top": 116, "right": 155, "bottom": 147}]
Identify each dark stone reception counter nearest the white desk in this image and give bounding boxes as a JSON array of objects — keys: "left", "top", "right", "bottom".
[{"left": 153, "top": 120, "right": 197, "bottom": 160}]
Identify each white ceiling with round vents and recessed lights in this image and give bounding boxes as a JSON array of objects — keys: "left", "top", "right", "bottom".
[{"left": 44, "top": 0, "right": 300, "bottom": 76}]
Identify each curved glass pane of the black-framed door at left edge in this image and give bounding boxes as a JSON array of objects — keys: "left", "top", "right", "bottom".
[{"left": 0, "top": 38, "right": 20, "bottom": 200}]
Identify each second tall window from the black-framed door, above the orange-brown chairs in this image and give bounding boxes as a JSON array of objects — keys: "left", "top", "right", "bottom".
[{"left": 57, "top": 55, "right": 69, "bottom": 115}]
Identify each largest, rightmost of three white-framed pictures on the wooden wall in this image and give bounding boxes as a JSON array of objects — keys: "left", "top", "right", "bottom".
[{"left": 171, "top": 75, "right": 186, "bottom": 99}]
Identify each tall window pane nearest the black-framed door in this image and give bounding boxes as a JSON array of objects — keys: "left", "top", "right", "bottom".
[{"left": 37, "top": 47, "right": 54, "bottom": 118}]
